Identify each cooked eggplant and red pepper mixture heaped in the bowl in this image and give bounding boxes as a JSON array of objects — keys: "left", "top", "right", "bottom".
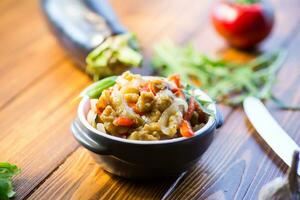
[{"left": 86, "top": 72, "right": 213, "bottom": 140}]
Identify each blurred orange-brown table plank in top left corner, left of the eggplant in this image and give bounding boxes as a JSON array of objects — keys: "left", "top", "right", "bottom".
[{"left": 0, "top": 1, "right": 65, "bottom": 109}]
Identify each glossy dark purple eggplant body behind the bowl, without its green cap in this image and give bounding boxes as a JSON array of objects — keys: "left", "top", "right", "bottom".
[{"left": 41, "top": 0, "right": 127, "bottom": 70}]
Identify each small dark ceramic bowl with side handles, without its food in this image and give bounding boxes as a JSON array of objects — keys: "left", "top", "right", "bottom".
[{"left": 71, "top": 83, "right": 223, "bottom": 179}]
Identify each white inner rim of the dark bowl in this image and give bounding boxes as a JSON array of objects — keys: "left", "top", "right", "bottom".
[{"left": 77, "top": 83, "right": 217, "bottom": 145}]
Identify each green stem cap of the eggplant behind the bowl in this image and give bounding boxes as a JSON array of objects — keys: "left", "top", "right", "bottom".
[{"left": 86, "top": 33, "right": 142, "bottom": 81}]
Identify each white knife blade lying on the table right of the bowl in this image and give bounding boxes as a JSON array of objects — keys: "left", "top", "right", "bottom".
[{"left": 243, "top": 97, "right": 300, "bottom": 171}]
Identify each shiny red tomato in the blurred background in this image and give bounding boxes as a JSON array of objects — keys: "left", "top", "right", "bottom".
[{"left": 212, "top": 1, "right": 274, "bottom": 48}]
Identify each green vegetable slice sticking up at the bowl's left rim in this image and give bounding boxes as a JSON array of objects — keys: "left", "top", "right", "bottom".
[{"left": 81, "top": 76, "right": 117, "bottom": 98}]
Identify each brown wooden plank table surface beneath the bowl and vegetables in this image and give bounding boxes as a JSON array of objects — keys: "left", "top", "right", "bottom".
[{"left": 0, "top": 0, "right": 300, "bottom": 200}]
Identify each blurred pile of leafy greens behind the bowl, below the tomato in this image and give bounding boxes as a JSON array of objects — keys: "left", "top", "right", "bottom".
[{"left": 152, "top": 41, "right": 300, "bottom": 110}]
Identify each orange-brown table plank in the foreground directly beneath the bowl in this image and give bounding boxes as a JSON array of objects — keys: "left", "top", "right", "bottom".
[{"left": 29, "top": 147, "right": 175, "bottom": 199}]
